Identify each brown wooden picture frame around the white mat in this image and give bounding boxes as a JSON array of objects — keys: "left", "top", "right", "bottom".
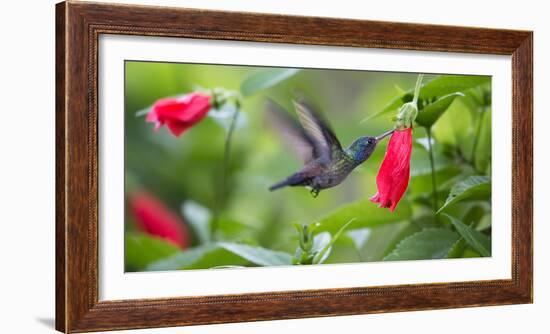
[{"left": 56, "top": 1, "right": 533, "bottom": 332}]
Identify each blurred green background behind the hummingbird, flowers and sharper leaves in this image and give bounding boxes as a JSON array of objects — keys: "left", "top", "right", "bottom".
[{"left": 125, "top": 61, "right": 491, "bottom": 271}]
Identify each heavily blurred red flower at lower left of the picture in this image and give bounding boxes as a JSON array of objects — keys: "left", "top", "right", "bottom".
[{"left": 130, "top": 192, "right": 189, "bottom": 249}]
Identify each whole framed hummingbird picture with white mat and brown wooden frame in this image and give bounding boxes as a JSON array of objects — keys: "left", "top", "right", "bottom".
[{"left": 56, "top": 1, "right": 533, "bottom": 332}]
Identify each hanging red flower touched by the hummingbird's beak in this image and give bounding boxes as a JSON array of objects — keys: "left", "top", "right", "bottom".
[{"left": 370, "top": 128, "right": 412, "bottom": 211}]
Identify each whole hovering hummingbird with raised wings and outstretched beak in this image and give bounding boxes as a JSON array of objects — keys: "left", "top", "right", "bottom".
[{"left": 267, "top": 96, "right": 394, "bottom": 197}]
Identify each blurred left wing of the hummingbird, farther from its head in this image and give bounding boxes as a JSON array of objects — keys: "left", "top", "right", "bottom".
[{"left": 266, "top": 99, "right": 315, "bottom": 163}]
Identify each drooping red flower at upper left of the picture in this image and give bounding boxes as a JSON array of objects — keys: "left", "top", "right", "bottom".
[{"left": 145, "top": 93, "right": 211, "bottom": 137}]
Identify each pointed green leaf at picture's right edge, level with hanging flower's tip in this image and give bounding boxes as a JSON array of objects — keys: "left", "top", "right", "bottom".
[{"left": 437, "top": 176, "right": 491, "bottom": 213}]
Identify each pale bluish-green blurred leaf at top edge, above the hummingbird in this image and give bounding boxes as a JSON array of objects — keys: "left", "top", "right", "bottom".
[{"left": 241, "top": 68, "right": 300, "bottom": 96}]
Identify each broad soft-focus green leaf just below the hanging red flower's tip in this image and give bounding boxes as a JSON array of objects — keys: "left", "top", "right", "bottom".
[{"left": 315, "top": 198, "right": 411, "bottom": 233}]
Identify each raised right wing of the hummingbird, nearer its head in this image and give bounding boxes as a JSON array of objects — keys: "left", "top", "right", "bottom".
[{"left": 294, "top": 97, "right": 342, "bottom": 161}]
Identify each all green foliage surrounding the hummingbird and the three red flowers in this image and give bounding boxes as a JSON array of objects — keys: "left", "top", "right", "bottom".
[{"left": 125, "top": 62, "right": 492, "bottom": 271}]
